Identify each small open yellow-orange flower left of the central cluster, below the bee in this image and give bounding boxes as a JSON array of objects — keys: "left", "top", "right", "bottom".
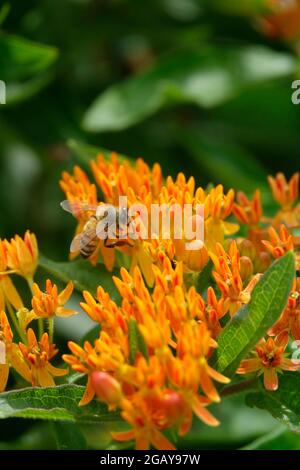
[{"left": 31, "top": 279, "right": 78, "bottom": 318}]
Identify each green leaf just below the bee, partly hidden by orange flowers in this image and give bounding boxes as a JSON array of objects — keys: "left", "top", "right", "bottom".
[{"left": 39, "top": 255, "right": 119, "bottom": 300}]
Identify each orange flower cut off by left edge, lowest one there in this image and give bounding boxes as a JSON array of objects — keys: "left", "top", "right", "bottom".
[{"left": 0, "top": 311, "right": 30, "bottom": 392}]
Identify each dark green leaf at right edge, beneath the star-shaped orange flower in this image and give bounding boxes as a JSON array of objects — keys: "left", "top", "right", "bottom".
[{"left": 246, "top": 372, "right": 300, "bottom": 439}]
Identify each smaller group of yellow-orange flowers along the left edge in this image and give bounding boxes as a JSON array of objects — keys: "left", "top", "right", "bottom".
[{"left": 0, "top": 231, "right": 71, "bottom": 391}]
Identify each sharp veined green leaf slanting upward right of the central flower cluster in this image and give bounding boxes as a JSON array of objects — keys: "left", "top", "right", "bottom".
[{"left": 212, "top": 252, "right": 295, "bottom": 377}]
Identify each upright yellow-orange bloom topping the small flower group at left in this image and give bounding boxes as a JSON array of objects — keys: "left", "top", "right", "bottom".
[{"left": 5, "top": 230, "right": 38, "bottom": 281}]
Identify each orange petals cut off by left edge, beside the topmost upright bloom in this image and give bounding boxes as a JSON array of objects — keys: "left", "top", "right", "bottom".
[{"left": 0, "top": 240, "right": 23, "bottom": 310}]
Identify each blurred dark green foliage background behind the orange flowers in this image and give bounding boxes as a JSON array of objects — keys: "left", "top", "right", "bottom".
[{"left": 0, "top": 0, "right": 300, "bottom": 449}]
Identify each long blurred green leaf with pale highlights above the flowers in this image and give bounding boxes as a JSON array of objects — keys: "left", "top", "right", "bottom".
[{"left": 83, "top": 46, "right": 296, "bottom": 132}]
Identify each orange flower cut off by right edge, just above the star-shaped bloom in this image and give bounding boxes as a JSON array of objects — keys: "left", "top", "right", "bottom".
[{"left": 269, "top": 278, "right": 300, "bottom": 340}]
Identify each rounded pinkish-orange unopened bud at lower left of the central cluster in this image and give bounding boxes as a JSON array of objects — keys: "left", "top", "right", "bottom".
[{"left": 91, "top": 372, "right": 122, "bottom": 405}]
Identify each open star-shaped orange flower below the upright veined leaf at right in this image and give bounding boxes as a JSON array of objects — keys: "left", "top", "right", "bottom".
[{"left": 237, "top": 332, "right": 300, "bottom": 391}]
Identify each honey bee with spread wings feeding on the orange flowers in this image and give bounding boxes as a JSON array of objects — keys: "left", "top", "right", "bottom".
[{"left": 61, "top": 200, "right": 133, "bottom": 258}]
